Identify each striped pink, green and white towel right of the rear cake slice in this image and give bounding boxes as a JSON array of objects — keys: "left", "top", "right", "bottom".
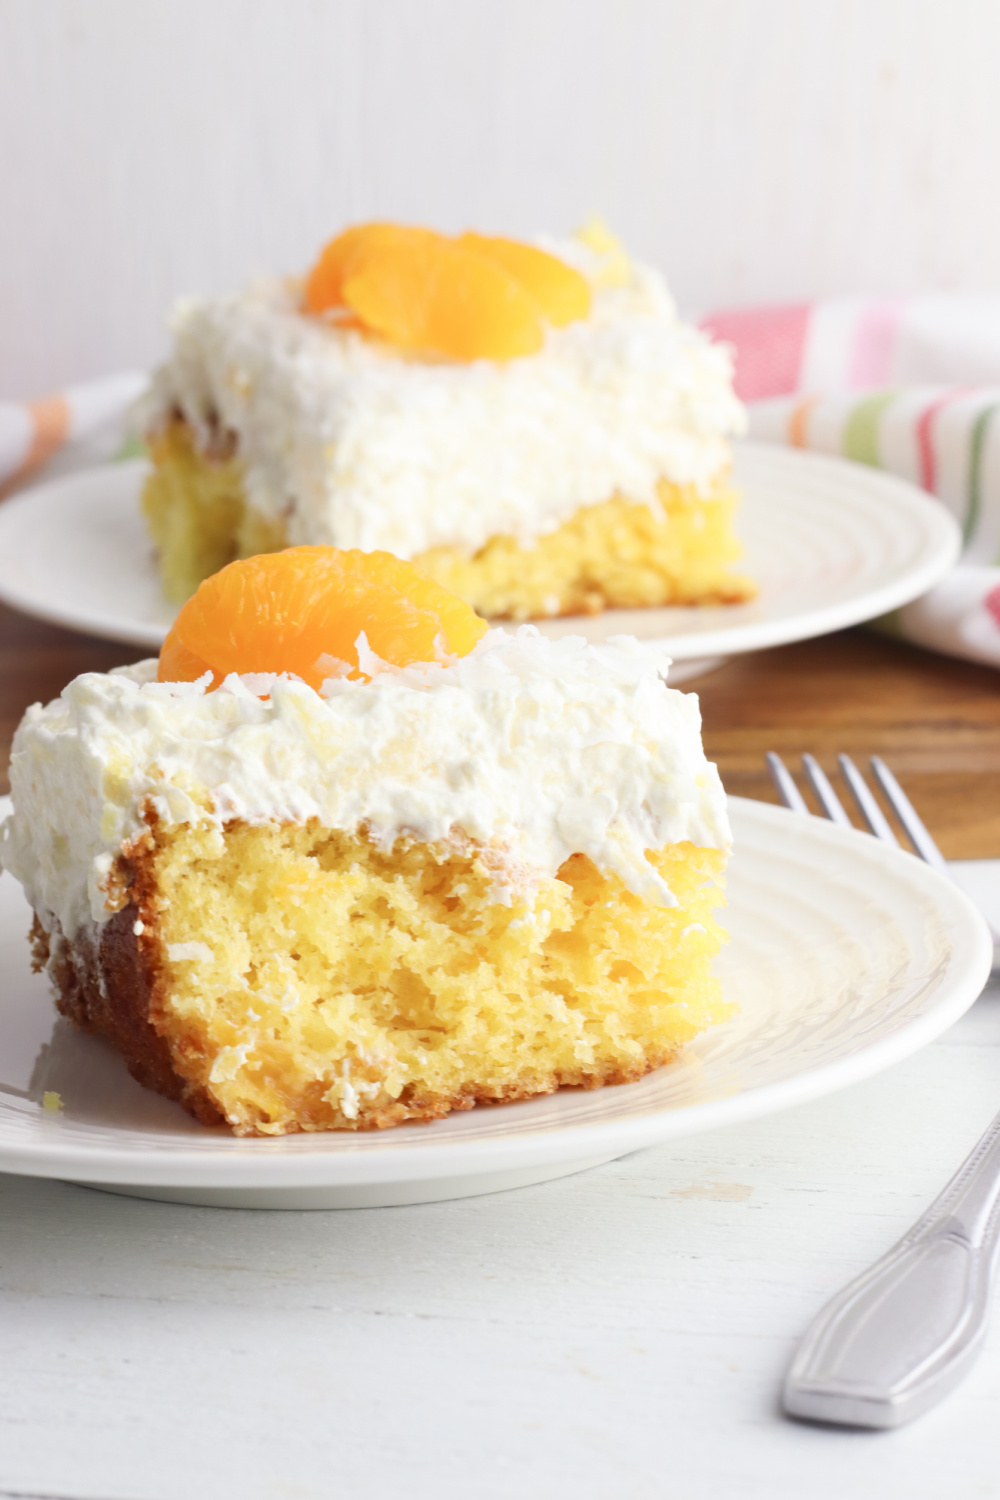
[{"left": 702, "top": 296, "right": 1000, "bottom": 666}]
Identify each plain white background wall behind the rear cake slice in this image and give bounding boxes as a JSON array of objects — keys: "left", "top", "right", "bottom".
[{"left": 0, "top": 0, "right": 1000, "bottom": 396}]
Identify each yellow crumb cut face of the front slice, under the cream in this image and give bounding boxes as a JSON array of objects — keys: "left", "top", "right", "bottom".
[{"left": 133, "top": 824, "right": 729, "bottom": 1134}]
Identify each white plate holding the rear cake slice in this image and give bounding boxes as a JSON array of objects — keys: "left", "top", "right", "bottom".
[{"left": 0, "top": 443, "right": 961, "bottom": 683}]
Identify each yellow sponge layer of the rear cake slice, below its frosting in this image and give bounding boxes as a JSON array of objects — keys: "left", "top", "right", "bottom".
[{"left": 142, "top": 422, "right": 754, "bottom": 620}]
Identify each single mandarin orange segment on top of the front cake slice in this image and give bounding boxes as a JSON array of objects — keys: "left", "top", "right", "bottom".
[{"left": 157, "top": 546, "right": 486, "bottom": 689}]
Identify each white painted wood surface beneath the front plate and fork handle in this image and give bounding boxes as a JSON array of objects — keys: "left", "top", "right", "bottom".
[{"left": 0, "top": 867, "right": 1000, "bottom": 1500}]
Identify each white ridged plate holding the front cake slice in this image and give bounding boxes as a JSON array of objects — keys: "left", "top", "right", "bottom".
[{"left": 0, "top": 798, "right": 993, "bottom": 1208}]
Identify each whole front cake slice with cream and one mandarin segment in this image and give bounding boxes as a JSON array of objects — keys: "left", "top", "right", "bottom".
[{"left": 1, "top": 548, "right": 729, "bottom": 1136}]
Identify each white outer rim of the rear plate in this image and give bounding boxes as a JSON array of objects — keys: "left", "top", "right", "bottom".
[{"left": 0, "top": 440, "right": 961, "bottom": 662}]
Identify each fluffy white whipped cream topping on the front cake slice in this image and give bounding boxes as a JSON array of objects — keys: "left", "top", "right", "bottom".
[{"left": 0, "top": 626, "right": 730, "bottom": 936}]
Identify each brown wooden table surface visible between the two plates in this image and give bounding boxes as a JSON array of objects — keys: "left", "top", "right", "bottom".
[{"left": 0, "top": 606, "right": 1000, "bottom": 860}]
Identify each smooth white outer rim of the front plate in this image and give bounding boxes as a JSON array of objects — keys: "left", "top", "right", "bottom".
[{"left": 0, "top": 797, "right": 993, "bottom": 1190}]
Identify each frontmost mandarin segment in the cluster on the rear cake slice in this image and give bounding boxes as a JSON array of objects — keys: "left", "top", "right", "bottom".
[{"left": 343, "top": 236, "right": 543, "bottom": 360}]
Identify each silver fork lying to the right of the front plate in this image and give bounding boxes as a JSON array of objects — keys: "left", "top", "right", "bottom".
[{"left": 768, "top": 753, "right": 1000, "bottom": 1428}]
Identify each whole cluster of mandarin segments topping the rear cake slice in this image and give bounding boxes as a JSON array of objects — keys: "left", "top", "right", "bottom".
[{"left": 303, "top": 224, "right": 591, "bottom": 360}]
